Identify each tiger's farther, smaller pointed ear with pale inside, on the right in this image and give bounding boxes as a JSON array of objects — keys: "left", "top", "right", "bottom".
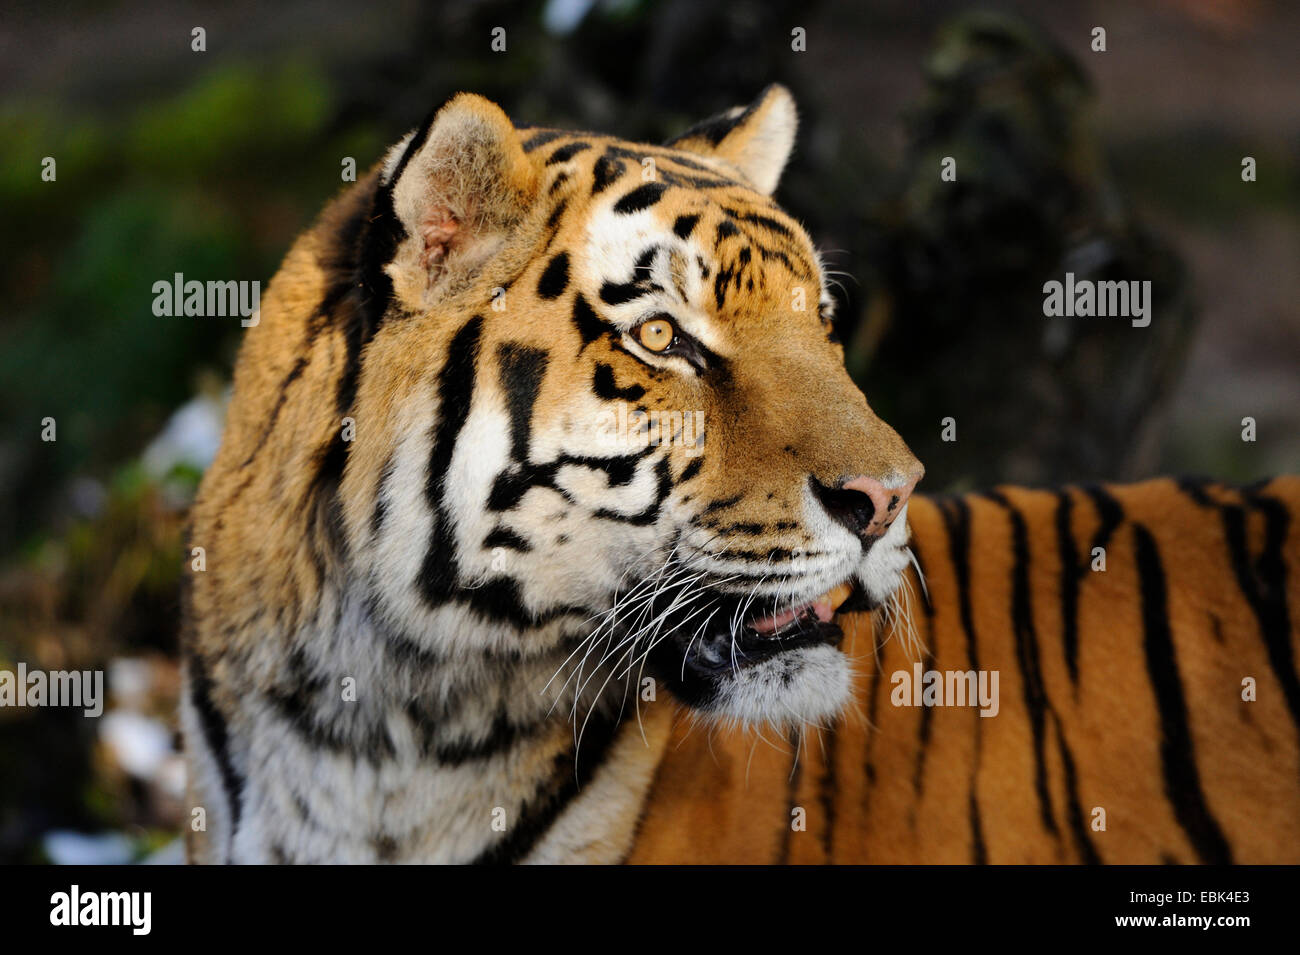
[{"left": 668, "top": 83, "right": 800, "bottom": 196}]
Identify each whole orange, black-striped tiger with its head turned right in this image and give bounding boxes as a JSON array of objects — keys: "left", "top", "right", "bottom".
[{"left": 181, "top": 86, "right": 1300, "bottom": 864}]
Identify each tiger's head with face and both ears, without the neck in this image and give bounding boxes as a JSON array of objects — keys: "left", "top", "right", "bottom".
[{"left": 342, "top": 87, "right": 923, "bottom": 724}]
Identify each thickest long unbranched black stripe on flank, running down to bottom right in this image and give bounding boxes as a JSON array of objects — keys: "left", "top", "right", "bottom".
[{"left": 1134, "top": 524, "right": 1232, "bottom": 865}]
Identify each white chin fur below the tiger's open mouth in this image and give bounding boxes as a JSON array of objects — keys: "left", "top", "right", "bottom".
[{"left": 709, "top": 646, "right": 852, "bottom": 728}]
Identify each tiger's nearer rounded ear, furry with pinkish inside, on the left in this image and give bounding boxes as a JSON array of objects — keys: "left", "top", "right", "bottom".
[{"left": 382, "top": 94, "right": 537, "bottom": 305}]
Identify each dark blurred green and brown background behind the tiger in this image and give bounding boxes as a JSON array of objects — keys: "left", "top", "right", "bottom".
[{"left": 0, "top": 0, "right": 1300, "bottom": 861}]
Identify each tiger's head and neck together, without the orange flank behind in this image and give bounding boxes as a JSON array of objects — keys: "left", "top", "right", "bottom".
[{"left": 182, "top": 86, "right": 923, "bottom": 861}]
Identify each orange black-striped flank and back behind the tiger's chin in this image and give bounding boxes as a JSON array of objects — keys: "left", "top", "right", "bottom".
[{"left": 629, "top": 478, "right": 1300, "bottom": 864}]
